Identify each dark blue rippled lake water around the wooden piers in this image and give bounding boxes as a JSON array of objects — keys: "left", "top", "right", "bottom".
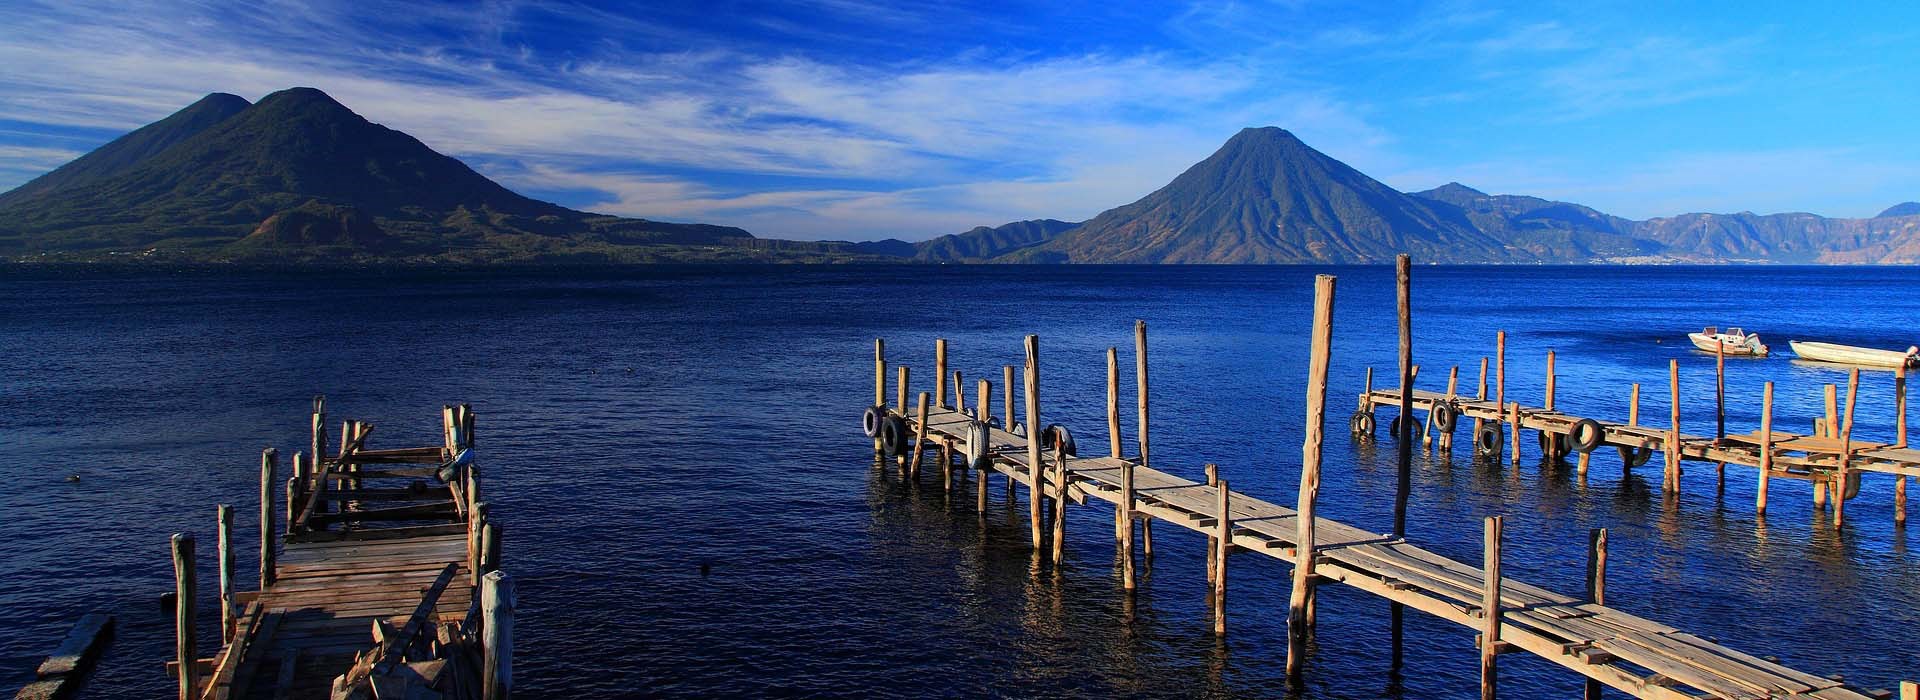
[{"left": 0, "top": 267, "right": 1920, "bottom": 698}]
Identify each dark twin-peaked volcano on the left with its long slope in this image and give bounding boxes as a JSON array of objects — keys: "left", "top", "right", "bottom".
[{"left": 0, "top": 88, "right": 866, "bottom": 263}]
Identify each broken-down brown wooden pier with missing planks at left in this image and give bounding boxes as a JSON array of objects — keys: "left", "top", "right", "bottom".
[{"left": 167, "top": 397, "right": 513, "bottom": 700}]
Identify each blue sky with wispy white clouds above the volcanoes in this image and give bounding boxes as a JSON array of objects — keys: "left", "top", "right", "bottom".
[{"left": 0, "top": 0, "right": 1920, "bottom": 240}]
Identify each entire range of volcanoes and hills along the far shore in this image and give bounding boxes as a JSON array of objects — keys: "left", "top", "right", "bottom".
[{"left": 0, "top": 88, "right": 1920, "bottom": 265}]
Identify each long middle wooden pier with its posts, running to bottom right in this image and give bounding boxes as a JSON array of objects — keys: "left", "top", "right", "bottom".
[{"left": 864, "top": 270, "right": 1920, "bottom": 700}]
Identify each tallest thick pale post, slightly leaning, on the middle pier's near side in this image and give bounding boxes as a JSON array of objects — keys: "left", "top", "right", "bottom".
[{"left": 1286, "top": 274, "right": 1334, "bottom": 688}]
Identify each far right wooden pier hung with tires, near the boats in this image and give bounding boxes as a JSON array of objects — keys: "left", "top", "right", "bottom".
[{"left": 1348, "top": 334, "right": 1920, "bottom": 527}]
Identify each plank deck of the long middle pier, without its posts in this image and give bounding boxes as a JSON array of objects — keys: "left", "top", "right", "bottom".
[{"left": 902, "top": 402, "right": 1872, "bottom": 700}]
